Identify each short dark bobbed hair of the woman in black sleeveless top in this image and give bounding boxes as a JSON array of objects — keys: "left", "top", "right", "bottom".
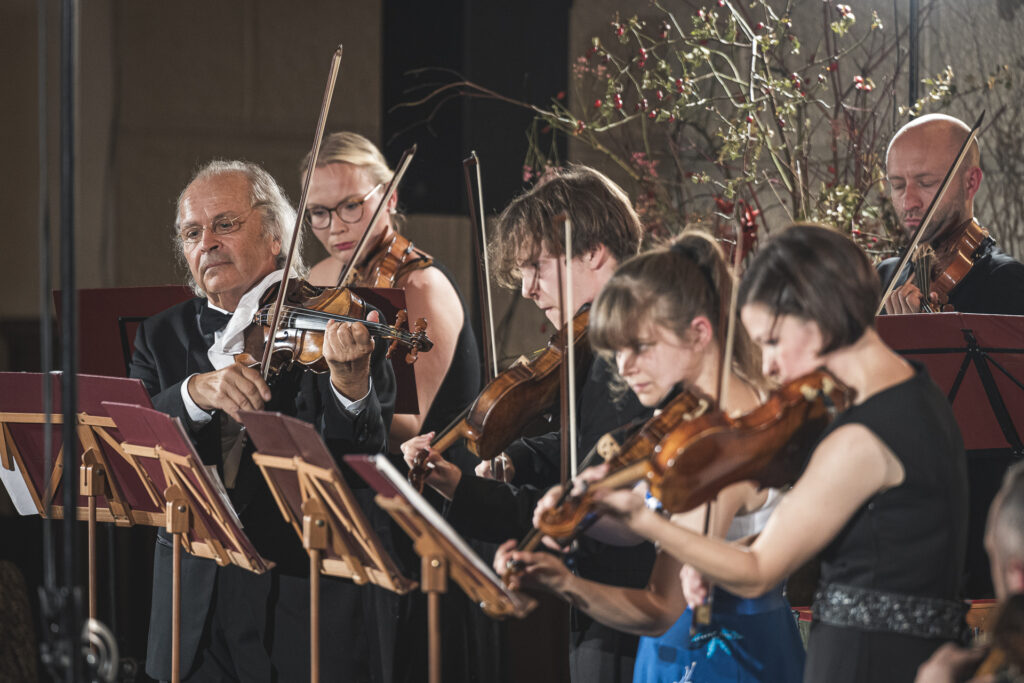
[{"left": 739, "top": 223, "right": 882, "bottom": 353}]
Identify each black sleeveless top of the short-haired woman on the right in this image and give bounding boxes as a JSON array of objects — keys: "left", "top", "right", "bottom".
[{"left": 821, "top": 364, "right": 968, "bottom": 600}]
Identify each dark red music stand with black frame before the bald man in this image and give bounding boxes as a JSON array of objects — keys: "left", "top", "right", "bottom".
[{"left": 876, "top": 312, "right": 1024, "bottom": 598}]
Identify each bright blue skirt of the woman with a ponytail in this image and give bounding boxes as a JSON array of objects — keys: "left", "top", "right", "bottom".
[{"left": 633, "top": 586, "right": 804, "bottom": 683}]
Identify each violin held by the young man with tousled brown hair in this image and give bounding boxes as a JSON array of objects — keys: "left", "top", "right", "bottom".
[{"left": 409, "top": 307, "right": 592, "bottom": 490}]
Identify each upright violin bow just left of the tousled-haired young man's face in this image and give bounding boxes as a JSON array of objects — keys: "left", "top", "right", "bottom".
[{"left": 462, "top": 151, "right": 505, "bottom": 481}]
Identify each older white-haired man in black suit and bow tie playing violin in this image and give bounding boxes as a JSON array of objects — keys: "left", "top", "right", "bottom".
[{"left": 131, "top": 161, "right": 394, "bottom": 681}]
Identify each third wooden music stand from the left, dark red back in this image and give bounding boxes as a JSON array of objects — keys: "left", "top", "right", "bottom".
[{"left": 241, "top": 411, "right": 416, "bottom": 683}]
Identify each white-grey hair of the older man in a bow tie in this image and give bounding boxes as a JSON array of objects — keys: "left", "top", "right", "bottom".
[{"left": 174, "top": 159, "right": 308, "bottom": 296}]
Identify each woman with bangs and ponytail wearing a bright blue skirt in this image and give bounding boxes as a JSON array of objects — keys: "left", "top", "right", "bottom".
[{"left": 496, "top": 232, "right": 804, "bottom": 683}]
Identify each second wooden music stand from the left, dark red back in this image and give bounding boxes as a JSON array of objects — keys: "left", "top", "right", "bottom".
[{"left": 103, "top": 401, "right": 273, "bottom": 683}]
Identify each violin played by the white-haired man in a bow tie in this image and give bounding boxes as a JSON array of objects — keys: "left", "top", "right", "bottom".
[{"left": 236, "top": 279, "right": 433, "bottom": 375}]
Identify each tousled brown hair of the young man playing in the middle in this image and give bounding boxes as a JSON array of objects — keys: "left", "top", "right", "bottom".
[{"left": 489, "top": 165, "right": 643, "bottom": 287}]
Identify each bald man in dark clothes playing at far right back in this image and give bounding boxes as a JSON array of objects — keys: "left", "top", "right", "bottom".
[{"left": 879, "top": 114, "right": 1024, "bottom": 315}]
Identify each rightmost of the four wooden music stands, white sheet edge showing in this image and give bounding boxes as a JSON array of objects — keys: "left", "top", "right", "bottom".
[{"left": 345, "top": 456, "right": 537, "bottom": 683}]
